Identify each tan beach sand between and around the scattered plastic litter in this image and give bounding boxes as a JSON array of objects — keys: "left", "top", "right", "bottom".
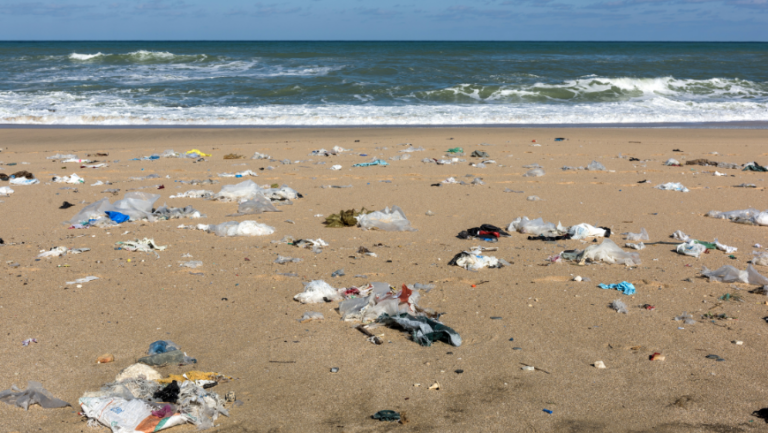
[{"left": 0, "top": 128, "right": 768, "bottom": 432}]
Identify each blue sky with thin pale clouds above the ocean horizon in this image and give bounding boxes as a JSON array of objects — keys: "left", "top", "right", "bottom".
[{"left": 0, "top": 0, "right": 768, "bottom": 41}]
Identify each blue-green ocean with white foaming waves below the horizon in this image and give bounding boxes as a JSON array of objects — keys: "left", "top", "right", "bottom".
[{"left": 0, "top": 41, "right": 768, "bottom": 127}]
